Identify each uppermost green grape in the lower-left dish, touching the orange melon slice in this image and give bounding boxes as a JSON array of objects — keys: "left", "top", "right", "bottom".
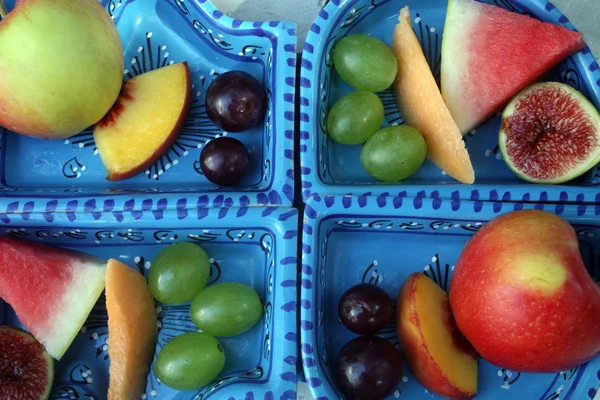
[{"left": 148, "top": 242, "right": 210, "bottom": 304}]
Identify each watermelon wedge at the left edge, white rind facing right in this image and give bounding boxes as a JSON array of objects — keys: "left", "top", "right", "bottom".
[{"left": 0, "top": 237, "right": 106, "bottom": 360}]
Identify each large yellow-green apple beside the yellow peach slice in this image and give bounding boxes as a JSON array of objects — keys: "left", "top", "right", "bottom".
[{"left": 0, "top": 0, "right": 123, "bottom": 139}]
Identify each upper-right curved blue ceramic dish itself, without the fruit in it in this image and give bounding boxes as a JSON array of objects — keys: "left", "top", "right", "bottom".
[{"left": 300, "top": 0, "right": 600, "bottom": 202}]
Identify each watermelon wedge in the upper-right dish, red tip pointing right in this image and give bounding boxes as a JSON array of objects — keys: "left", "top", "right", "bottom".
[{"left": 441, "top": 0, "right": 585, "bottom": 135}]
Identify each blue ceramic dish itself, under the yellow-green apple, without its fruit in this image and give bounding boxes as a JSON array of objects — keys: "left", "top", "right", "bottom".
[{"left": 0, "top": 0, "right": 296, "bottom": 211}]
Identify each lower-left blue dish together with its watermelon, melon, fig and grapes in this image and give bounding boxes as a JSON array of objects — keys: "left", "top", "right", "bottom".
[{"left": 0, "top": 207, "right": 297, "bottom": 400}]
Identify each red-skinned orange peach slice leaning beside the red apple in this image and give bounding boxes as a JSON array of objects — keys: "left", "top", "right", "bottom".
[{"left": 397, "top": 273, "right": 477, "bottom": 399}]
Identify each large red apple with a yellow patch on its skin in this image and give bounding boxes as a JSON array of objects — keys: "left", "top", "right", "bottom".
[{"left": 450, "top": 211, "right": 600, "bottom": 372}]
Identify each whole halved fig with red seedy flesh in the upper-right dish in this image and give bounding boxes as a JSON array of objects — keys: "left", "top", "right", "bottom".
[{"left": 499, "top": 82, "right": 600, "bottom": 184}]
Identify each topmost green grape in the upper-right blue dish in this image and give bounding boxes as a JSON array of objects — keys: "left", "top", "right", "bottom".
[{"left": 333, "top": 35, "right": 398, "bottom": 93}]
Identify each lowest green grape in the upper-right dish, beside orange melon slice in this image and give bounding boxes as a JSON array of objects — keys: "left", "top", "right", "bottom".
[{"left": 360, "top": 125, "right": 427, "bottom": 182}]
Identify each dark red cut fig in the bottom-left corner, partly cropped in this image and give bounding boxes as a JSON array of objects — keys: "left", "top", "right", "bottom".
[{"left": 0, "top": 326, "right": 54, "bottom": 400}]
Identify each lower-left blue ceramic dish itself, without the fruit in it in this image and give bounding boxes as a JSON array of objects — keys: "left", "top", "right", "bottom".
[{"left": 0, "top": 207, "right": 297, "bottom": 400}]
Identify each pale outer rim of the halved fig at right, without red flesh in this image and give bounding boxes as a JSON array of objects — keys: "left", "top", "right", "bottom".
[{"left": 498, "top": 82, "right": 600, "bottom": 184}]
